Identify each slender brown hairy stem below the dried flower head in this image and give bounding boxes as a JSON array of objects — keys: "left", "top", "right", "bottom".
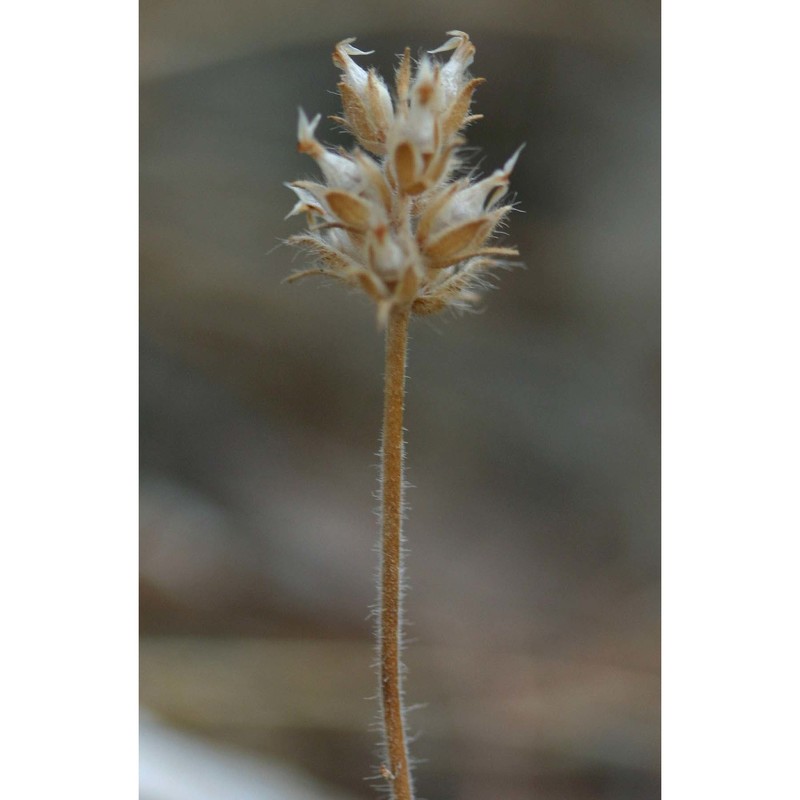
[{"left": 378, "top": 308, "right": 413, "bottom": 800}]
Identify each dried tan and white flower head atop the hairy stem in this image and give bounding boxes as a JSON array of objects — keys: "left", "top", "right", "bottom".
[{"left": 287, "top": 31, "right": 522, "bottom": 323}]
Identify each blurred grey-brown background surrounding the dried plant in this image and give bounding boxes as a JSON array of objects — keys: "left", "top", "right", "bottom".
[{"left": 140, "top": 0, "right": 660, "bottom": 800}]
